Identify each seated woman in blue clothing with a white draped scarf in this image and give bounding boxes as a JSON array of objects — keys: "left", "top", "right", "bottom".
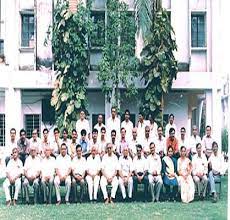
[{"left": 162, "top": 146, "right": 178, "bottom": 201}]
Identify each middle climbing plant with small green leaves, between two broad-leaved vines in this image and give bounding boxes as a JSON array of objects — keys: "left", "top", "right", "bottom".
[{"left": 98, "top": 0, "right": 137, "bottom": 106}]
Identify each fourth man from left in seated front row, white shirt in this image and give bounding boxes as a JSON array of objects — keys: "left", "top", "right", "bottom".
[{"left": 54, "top": 143, "right": 71, "bottom": 205}]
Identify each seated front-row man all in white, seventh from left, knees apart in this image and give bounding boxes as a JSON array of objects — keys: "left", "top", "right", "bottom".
[{"left": 101, "top": 143, "right": 119, "bottom": 204}]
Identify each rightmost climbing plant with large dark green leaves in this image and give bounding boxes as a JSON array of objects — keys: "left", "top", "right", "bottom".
[{"left": 140, "top": 8, "right": 178, "bottom": 121}]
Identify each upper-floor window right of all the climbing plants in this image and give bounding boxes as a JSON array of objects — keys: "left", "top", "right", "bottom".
[{"left": 191, "top": 14, "right": 206, "bottom": 47}]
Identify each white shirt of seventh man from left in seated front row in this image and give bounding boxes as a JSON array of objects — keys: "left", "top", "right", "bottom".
[{"left": 101, "top": 154, "right": 119, "bottom": 178}]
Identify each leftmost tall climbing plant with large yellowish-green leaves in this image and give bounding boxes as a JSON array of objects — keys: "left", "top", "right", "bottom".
[{"left": 51, "top": 1, "right": 92, "bottom": 130}]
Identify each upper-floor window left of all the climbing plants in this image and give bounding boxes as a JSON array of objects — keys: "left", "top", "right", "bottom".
[{"left": 21, "top": 14, "right": 34, "bottom": 48}]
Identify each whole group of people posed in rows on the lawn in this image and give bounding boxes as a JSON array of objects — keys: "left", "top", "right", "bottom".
[{"left": 0, "top": 108, "right": 225, "bottom": 206}]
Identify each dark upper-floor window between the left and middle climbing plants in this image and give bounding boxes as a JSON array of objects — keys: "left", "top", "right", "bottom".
[{"left": 90, "top": 11, "right": 105, "bottom": 47}]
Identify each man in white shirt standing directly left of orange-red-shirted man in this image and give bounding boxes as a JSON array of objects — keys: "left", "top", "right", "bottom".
[{"left": 154, "top": 125, "right": 167, "bottom": 158}]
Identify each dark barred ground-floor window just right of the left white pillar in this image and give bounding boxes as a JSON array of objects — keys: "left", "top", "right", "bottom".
[{"left": 25, "top": 115, "right": 40, "bottom": 138}]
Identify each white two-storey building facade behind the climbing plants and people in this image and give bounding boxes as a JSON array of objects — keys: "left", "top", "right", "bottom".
[{"left": 0, "top": 0, "right": 225, "bottom": 146}]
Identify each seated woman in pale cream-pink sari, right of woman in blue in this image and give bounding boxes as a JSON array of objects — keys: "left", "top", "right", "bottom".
[{"left": 177, "top": 146, "right": 195, "bottom": 203}]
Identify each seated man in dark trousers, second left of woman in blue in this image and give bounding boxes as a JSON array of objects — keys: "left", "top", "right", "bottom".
[{"left": 133, "top": 144, "right": 149, "bottom": 202}]
